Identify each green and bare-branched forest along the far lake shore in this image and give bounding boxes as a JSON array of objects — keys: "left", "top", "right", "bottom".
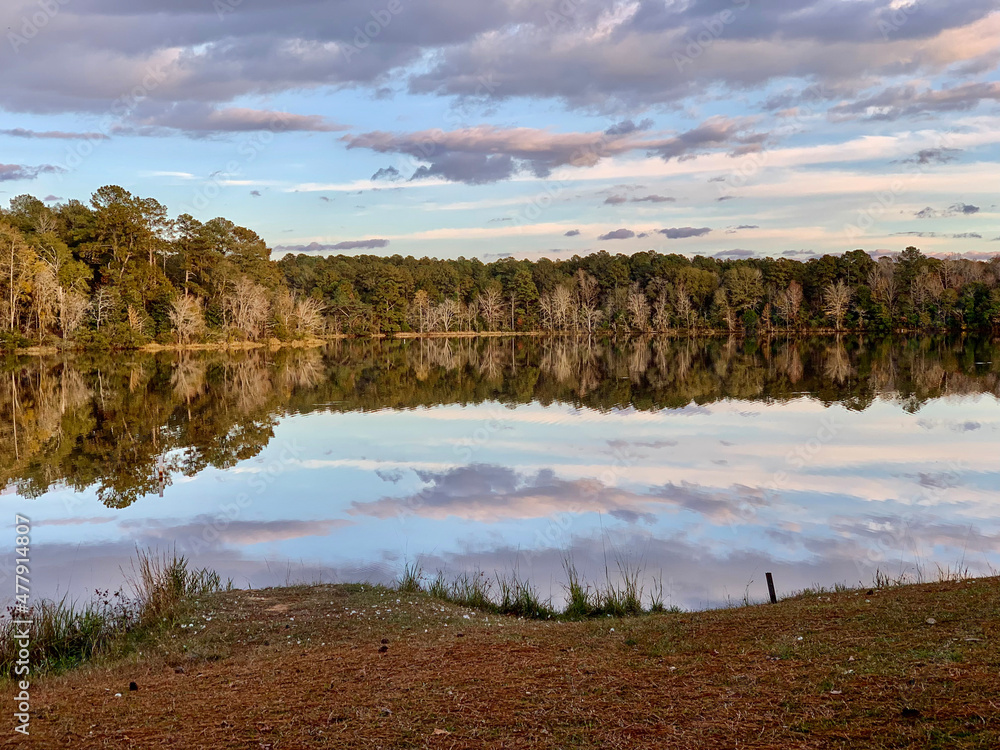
[{"left": 0, "top": 185, "right": 1000, "bottom": 349}]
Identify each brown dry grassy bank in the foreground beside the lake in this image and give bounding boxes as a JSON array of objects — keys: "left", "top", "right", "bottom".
[{"left": 0, "top": 578, "right": 1000, "bottom": 750}]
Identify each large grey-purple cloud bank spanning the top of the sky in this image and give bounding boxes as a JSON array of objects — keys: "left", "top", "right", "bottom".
[{"left": 0, "top": 0, "right": 996, "bottom": 126}]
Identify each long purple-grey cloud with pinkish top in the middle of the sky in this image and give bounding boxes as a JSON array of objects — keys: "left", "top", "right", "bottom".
[{"left": 342, "top": 117, "right": 763, "bottom": 184}]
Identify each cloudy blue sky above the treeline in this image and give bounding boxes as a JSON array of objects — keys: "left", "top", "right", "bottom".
[{"left": 0, "top": 0, "right": 1000, "bottom": 260}]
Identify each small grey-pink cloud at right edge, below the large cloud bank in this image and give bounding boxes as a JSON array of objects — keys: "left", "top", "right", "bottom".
[{"left": 829, "top": 82, "right": 1000, "bottom": 120}]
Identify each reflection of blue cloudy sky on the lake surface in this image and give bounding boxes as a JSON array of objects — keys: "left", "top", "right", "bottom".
[{"left": 7, "top": 394, "right": 1000, "bottom": 609}]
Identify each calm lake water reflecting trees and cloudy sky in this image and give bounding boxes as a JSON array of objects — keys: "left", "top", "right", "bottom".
[{"left": 0, "top": 338, "right": 1000, "bottom": 607}]
